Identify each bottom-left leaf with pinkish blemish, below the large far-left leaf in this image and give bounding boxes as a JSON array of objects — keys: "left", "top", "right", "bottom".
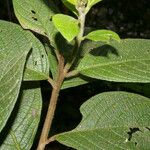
[{"left": 0, "top": 82, "right": 42, "bottom": 150}]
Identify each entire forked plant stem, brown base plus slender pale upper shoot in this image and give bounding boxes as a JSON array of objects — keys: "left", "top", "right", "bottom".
[{"left": 37, "top": 2, "right": 86, "bottom": 150}]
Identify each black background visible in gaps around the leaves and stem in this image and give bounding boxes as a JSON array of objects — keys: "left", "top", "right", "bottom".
[{"left": 0, "top": 0, "right": 150, "bottom": 150}]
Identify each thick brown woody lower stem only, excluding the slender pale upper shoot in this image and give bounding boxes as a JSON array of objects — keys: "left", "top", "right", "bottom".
[{"left": 37, "top": 56, "right": 67, "bottom": 150}]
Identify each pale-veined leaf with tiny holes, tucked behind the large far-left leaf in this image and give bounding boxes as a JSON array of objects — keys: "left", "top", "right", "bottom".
[{"left": 24, "top": 32, "right": 49, "bottom": 81}]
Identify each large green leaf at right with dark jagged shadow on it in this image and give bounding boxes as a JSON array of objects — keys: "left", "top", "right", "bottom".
[{"left": 77, "top": 39, "right": 150, "bottom": 83}]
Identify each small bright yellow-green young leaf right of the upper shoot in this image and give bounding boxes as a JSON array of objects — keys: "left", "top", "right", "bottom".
[{"left": 85, "top": 30, "right": 120, "bottom": 42}]
